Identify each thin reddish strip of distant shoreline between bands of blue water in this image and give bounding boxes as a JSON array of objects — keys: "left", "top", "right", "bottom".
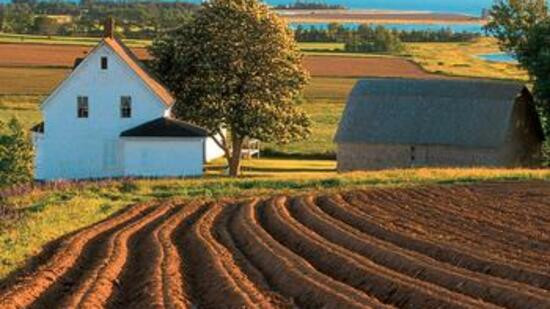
[{"left": 276, "top": 10, "right": 487, "bottom": 25}]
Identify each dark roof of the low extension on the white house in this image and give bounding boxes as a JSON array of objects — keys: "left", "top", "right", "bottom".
[{"left": 120, "top": 118, "right": 208, "bottom": 137}]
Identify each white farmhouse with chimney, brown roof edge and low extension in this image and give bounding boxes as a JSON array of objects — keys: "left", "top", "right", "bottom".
[{"left": 33, "top": 21, "right": 223, "bottom": 180}]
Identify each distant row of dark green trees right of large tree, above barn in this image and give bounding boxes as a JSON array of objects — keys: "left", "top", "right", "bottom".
[{"left": 294, "top": 23, "right": 481, "bottom": 43}]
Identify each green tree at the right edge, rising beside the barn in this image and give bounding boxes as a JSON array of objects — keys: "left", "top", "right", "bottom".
[{"left": 485, "top": 0, "right": 550, "bottom": 134}]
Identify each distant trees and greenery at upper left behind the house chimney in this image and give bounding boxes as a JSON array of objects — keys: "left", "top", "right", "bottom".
[{"left": 0, "top": 0, "right": 197, "bottom": 38}]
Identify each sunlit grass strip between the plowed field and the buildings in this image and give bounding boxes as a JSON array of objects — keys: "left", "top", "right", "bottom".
[{"left": 0, "top": 167, "right": 550, "bottom": 278}]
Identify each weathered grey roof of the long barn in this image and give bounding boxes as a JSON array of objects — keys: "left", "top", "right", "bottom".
[{"left": 335, "top": 79, "right": 543, "bottom": 148}]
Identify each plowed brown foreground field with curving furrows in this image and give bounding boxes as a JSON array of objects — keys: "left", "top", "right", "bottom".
[{"left": 0, "top": 183, "right": 550, "bottom": 308}]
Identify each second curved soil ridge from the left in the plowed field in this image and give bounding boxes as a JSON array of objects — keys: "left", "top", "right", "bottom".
[{"left": 58, "top": 204, "right": 173, "bottom": 308}]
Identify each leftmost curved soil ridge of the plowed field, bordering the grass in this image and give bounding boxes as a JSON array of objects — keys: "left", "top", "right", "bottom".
[{"left": 0, "top": 203, "right": 157, "bottom": 308}]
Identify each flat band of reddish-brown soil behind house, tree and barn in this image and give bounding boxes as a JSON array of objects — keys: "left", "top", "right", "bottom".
[{"left": 0, "top": 44, "right": 441, "bottom": 78}]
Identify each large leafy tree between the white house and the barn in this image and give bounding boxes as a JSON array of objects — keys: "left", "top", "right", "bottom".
[{"left": 150, "top": 0, "right": 310, "bottom": 176}]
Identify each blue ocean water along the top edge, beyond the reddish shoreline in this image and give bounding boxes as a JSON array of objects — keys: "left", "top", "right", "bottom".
[{"left": 0, "top": 0, "right": 493, "bottom": 16}]
